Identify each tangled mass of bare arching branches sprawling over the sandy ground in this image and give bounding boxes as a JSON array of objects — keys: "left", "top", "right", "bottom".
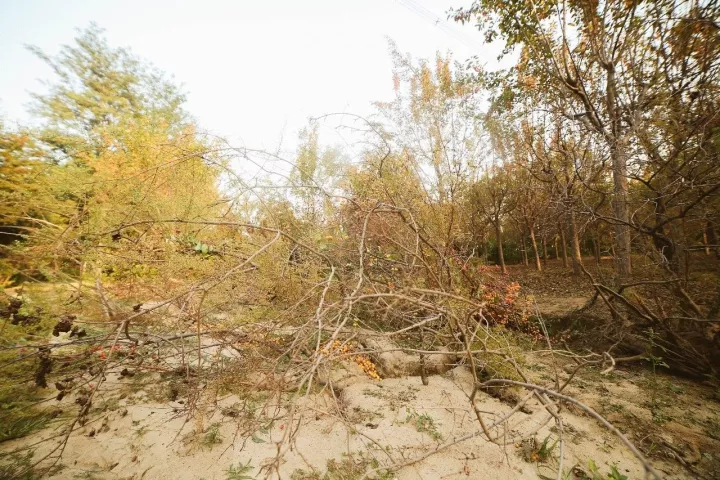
[{"left": 2, "top": 198, "right": 659, "bottom": 478}]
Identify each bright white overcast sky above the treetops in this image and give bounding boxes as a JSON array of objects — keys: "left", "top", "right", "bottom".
[{"left": 0, "top": 0, "right": 506, "bottom": 154}]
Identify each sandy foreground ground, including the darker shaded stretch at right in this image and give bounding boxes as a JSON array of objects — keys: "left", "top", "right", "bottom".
[{"left": 5, "top": 282, "right": 720, "bottom": 480}]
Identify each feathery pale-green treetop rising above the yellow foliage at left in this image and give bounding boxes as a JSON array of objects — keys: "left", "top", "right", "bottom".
[{"left": 29, "top": 24, "right": 188, "bottom": 161}]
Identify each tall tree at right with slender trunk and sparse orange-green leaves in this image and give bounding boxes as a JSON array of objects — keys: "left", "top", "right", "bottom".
[{"left": 453, "top": 0, "right": 720, "bottom": 281}]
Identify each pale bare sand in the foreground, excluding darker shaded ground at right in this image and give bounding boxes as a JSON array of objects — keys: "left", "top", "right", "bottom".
[{"left": 2, "top": 358, "right": 717, "bottom": 480}]
